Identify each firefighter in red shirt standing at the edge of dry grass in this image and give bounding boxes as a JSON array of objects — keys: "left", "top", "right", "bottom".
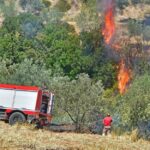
[{"left": 103, "top": 114, "right": 112, "bottom": 135}]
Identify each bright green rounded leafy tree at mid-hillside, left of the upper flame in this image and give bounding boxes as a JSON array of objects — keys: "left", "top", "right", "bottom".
[{"left": 40, "top": 24, "right": 86, "bottom": 77}]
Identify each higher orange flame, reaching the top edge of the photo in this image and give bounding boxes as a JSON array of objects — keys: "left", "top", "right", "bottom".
[{"left": 102, "top": 1, "right": 115, "bottom": 44}]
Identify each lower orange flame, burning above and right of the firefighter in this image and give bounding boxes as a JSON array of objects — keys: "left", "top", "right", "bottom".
[{"left": 118, "top": 59, "right": 130, "bottom": 94}]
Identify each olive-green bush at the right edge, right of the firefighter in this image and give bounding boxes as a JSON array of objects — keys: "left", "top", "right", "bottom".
[{"left": 120, "top": 74, "right": 150, "bottom": 127}]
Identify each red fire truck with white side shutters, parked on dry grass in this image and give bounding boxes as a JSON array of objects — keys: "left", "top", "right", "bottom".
[{"left": 0, "top": 84, "right": 54, "bottom": 125}]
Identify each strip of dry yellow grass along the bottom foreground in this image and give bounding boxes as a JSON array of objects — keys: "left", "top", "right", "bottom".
[{"left": 0, "top": 122, "right": 150, "bottom": 150}]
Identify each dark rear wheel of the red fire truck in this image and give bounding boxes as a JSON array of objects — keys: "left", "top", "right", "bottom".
[{"left": 9, "top": 112, "right": 26, "bottom": 125}]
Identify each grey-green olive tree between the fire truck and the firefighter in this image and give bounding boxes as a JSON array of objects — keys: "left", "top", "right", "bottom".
[{"left": 50, "top": 74, "right": 103, "bottom": 131}]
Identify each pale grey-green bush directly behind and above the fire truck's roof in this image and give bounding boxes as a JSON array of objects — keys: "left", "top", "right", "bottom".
[{"left": 8, "top": 59, "right": 52, "bottom": 86}]
